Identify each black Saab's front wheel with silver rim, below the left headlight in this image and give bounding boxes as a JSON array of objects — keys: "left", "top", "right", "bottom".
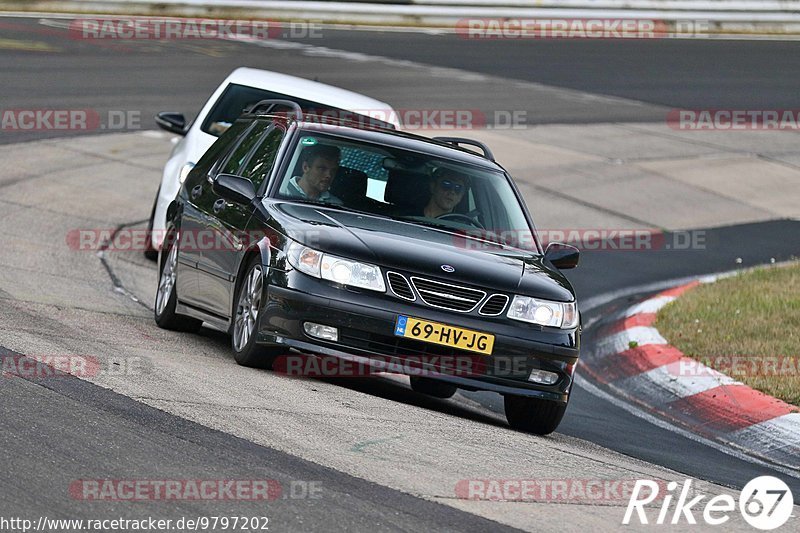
[{"left": 230, "top": 255, "right": 279, "bottom": 369}]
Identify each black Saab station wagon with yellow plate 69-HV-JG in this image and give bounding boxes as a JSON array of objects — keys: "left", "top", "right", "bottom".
[{"left": 155, "top": 100, "right": 580, "bottom": 434}]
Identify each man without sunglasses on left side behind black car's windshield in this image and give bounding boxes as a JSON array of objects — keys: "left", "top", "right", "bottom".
[{"left": 287, "top": 144, "right": 344, "bottom": 205}]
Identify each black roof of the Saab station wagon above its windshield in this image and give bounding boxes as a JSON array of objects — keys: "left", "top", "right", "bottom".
[{"left": 243, "top": 113, "right": 505, "bottom": 172}]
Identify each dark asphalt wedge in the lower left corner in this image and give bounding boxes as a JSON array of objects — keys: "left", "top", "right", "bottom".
[{"left": 0, "top": 342, "right": 514, "bottom": 531}]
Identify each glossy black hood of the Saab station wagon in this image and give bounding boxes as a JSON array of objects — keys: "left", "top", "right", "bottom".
[{"left": 266, "top": 202, "right": 574, "bottom": 301}]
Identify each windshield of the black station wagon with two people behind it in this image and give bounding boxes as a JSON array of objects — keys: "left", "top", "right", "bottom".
[{"left": 278, "top": 132, "right": 538, "bottom": 252}]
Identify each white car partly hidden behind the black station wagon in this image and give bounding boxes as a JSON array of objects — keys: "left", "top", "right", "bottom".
[{"left": 145, "top": 68, "right": 400, "bottom": 259}]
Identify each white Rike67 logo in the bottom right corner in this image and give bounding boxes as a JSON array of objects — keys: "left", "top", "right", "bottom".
[{"left": 622, "top": 476, "right": 794, "bottom": 531}]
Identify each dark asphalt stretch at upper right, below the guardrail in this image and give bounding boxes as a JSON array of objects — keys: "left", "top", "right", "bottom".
[{"left": 290, "top": 31, "right": 800, "bottom": 111}]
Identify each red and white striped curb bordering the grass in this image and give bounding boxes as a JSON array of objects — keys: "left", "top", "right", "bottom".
[{"left": 582, "top": 277, "right": 800, "bottom": 470}]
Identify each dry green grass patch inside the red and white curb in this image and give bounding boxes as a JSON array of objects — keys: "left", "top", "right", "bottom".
[{"left": 656, "top": 263, "right": 800, "bottom": 406}]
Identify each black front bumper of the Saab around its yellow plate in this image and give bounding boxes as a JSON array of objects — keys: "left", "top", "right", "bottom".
[{"left": 259, "top": 272, "right": 579, "bottom": 402}]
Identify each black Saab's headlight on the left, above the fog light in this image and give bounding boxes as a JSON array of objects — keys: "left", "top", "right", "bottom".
[{"left": 286, "top": 242, "right": 386, "bottom": 292}]
